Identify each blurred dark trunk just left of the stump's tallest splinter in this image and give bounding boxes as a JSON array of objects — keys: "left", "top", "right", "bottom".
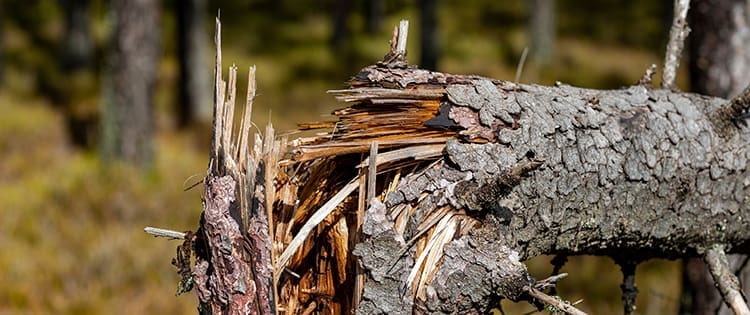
[{"left": 175, "top": 0, "right": 211, "bottom": 128}]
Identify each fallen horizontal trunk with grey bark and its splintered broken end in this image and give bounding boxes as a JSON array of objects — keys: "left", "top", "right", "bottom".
[{"left": 276, "top": 31, "right": 750, "bottom": 314}]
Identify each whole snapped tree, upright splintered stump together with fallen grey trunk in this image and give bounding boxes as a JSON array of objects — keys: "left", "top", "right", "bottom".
[{"left": 145, "top": 16, "right": 750, "bottom": 314}]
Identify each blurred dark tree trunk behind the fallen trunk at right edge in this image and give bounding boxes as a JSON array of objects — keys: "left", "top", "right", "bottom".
[{"left": 682, "top": 0, "right": 750, "bottom": 314}]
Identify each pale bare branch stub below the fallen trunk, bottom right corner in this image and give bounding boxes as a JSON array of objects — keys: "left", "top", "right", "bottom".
[{"left": 703, "top": 244, "right": 750, "bottom": 315}]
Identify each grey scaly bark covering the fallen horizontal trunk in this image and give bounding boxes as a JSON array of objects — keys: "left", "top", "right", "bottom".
[{"left": 353, "top": 67, "right": 750, "bottom": 314}]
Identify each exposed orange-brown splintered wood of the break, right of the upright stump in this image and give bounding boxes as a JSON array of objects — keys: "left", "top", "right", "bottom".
[{"left": 274, "top": 22, "right": 475, "bottom": 314}]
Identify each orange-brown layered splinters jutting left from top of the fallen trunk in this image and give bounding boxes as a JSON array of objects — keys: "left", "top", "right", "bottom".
[{"left": 293, "top": 87, "right": 455, "bottom": 161}]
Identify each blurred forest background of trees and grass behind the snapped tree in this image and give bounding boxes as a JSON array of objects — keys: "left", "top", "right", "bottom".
[{"left": 0, "top": 0, "right": 700, "bottom": 314}]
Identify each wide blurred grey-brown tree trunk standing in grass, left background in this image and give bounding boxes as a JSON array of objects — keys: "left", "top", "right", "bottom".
[{"left": 101, "top": 0, "right": 160, "bottom": 167}]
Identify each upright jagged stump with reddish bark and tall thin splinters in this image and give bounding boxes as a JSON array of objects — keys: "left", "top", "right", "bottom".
[{"left": 191, "top": 19, "right": 278, "bottom": 314}]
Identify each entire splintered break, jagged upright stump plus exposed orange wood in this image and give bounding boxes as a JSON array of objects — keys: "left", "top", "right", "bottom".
[{"left": 192, "top": 20, "right": 482, "bottom": 314}]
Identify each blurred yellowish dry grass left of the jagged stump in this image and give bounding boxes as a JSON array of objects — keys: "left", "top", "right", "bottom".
[{"left": 0, "top": 95, "right": 205, "bottom": 314}]
